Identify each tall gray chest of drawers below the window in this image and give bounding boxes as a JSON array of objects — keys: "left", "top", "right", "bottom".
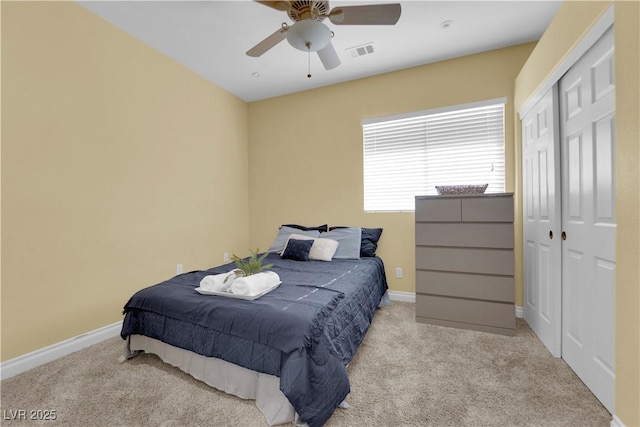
[{"left": 415, "top": 193, "right": 515, "bottom": 335}]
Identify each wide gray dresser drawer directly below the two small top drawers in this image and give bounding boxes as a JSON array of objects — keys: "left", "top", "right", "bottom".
[{"left": 416, "top": 222, "right": 513, "bottom": 249}]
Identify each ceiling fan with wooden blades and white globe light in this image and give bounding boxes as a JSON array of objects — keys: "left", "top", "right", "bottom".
[{"left": 247, "top": 0, "right": 401, "bottom": 77}]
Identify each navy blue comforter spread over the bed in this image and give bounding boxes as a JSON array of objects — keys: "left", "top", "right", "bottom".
[{"left": 121, "top": 254, "right": 387, "bottom": 427}]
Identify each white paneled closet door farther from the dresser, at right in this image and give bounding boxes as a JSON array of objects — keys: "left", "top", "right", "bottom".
[{"left": 559, "top": 28, "right": 616, "bottom": 413}]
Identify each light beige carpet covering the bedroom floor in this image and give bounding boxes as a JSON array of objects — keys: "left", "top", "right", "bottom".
[{"left": 0, "top": 302, "right": 611, "bottom": 427}]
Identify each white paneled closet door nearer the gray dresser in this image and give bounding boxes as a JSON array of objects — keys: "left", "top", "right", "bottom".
[{"left": 522, "top": 86, "right": 562, "bottom": 357}]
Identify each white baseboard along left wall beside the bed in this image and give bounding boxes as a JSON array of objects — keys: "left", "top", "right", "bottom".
[{"left": 0, "top": 321, "right": 122, "bottom": 380}]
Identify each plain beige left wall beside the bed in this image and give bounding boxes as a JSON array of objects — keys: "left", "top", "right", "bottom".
[{"left": 2, "top": 2, "right": 249, "bottom": 360}]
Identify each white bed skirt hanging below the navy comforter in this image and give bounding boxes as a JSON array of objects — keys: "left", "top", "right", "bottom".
[{"left": 125, "top": 335, "right": 305, "bottom": 426}]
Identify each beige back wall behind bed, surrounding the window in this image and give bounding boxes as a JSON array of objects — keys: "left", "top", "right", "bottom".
[{"left": 249, "top": 43, "right": 534, "bottom": 292}]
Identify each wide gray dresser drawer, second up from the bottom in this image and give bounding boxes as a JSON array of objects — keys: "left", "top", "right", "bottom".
[{"left": 416, "top": 270, "right": 515, "bottom": 303}]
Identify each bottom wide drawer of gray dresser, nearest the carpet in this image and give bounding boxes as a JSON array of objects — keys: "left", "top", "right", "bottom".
[{"left": 416, "top": 295, "right": 516, "bottom": 329}]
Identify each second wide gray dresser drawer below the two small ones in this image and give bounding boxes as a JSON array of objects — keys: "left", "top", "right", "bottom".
[{"left": 416, "top": 246, "right": 514, "bottom": 276}]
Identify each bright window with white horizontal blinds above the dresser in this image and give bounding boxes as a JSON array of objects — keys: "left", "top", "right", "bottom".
[{"left": 362, "top": 98, "right": 506, "bottom": 211}]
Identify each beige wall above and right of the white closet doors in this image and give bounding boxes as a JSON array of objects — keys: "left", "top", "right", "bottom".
[{"left": 515, "top": 1, "right": 640, "bottom": 426}]
